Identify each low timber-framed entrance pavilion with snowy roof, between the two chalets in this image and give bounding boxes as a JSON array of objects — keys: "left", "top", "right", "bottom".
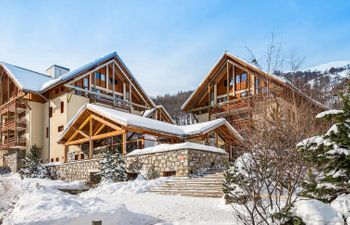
[{"left": 59, "top": 104, "right": 243, "bottom": 162}]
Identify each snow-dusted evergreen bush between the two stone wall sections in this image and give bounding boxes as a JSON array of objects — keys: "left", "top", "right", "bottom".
[{"left": 98, "top": 149, "right": 127, "bottom": 182}]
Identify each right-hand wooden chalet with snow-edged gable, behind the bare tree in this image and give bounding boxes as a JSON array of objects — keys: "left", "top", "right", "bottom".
[{"left": 182, "top": 52, "right": 324, "bottom": 131}]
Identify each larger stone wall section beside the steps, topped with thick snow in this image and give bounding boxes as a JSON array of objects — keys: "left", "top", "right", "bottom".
[{"left": 126, "top": 149, "right": 228, "bottom": 176}]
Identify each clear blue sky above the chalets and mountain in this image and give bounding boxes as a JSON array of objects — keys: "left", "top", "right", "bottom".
[{"left": 0, "top": 0, "right": 350, "bottom": 96}]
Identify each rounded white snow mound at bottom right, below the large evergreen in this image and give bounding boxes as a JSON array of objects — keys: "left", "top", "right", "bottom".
[{"left": 292, "top": 199, "right": 344, "bottom": 225}]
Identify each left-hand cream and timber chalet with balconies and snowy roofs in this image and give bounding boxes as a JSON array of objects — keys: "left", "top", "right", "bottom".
[{"left": 0, "top": 52, "right": 173, "bottom": 170}]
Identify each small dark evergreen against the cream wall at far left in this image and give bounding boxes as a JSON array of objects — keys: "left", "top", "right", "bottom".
[{"left": 19, "top": 145, "right": 48, "bottom": 178}]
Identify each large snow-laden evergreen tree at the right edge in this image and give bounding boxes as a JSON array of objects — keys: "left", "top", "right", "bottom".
[{"left": 298, "top": 91, "right": 350, "bottom": 202}]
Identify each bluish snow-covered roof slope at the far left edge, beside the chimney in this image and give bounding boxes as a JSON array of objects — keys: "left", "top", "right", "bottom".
[{"left": 0, "top": 62, "right": 53, "bottom": 92}]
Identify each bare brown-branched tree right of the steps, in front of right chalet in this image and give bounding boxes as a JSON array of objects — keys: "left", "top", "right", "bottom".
[{"left": 224, "top": 95, "right": 321, "bottom": 225}]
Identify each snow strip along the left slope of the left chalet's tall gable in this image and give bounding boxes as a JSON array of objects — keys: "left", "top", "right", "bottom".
[{"left": 41, "top": 52, "right": 117, "bottom": 91}]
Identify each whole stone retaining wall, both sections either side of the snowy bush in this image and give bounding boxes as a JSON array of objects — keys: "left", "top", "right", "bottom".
[{"left": 47, "top": 149, "right": 228, "bottom": 181}]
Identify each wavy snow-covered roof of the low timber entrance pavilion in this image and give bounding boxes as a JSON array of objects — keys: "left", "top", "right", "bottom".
[{"left": 58, "top": 104, "right": 243, "bottom": 141}]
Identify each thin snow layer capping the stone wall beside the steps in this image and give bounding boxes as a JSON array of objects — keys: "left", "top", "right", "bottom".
[{"left": 126, "top": 142, "right": 227, "bottom": 156}]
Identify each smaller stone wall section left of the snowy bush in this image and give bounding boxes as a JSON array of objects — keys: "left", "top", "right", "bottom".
[{"left": 47, "top": 159, "right": 100, "bottom": 181}]
